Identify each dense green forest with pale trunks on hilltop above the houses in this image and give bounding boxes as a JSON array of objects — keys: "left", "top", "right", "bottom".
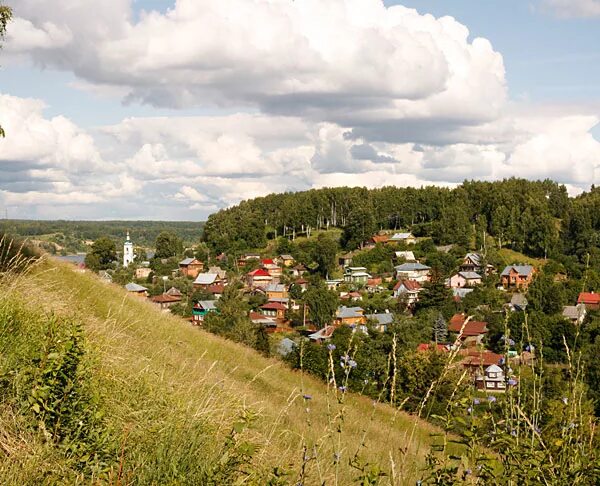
[{"left": 204, "top": 178, "right": 600, "bottom": 262}]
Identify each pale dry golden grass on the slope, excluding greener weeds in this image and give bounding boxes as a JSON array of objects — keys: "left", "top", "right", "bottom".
[{"left": 1, "top": 261, "right": 450, "bottom": 484}]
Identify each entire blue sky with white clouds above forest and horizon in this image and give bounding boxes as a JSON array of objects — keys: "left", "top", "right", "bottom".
[{"left": 0, "top": 0, "right": 600, "bottom": 220}]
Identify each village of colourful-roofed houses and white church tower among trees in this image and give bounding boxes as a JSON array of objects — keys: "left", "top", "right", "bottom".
[{"left": 83, "top": 232, "right": 600, "bottom": 393}]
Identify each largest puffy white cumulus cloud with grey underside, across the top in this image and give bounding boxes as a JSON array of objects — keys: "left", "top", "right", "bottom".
[{"left": 8, "top": 0, "right": 506, "bottom": 143}]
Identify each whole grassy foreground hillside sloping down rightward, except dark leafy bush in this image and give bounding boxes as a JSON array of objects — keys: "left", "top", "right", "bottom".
[{"left": 0, "top": 261, "right": 450, "bottom": 484}]
